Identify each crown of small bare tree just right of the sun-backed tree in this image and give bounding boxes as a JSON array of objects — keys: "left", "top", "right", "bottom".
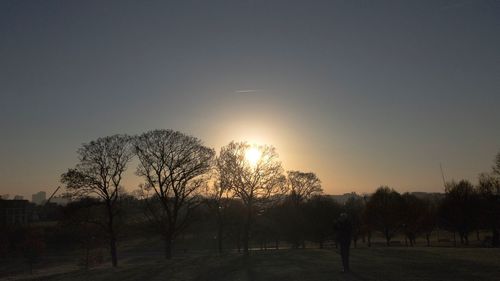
[{"left": 287, "top": 171, "right": 323, "bottom": 205}]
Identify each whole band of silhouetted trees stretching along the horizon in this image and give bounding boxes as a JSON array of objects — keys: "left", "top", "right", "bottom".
[{"left": 0, "top": 130, "right": 500, "bottom": 266}]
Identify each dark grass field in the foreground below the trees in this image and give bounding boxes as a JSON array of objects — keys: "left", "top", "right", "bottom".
[{"left": 6, "top": 247, "right": 500, "bottom": 281}]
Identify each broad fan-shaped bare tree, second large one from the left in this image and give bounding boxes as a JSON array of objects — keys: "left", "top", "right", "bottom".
[{"left": 134, "top": 130, "right": 215, "bottom": 259}]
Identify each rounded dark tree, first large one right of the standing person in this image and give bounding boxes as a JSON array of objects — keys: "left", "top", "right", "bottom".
[{"left": 366, "top": 186, "right": 403, "bottom": 246}]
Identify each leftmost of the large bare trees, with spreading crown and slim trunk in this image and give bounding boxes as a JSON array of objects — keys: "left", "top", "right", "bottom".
[{"left": 61, "top": 135, "right": 133, "bottom": 267}]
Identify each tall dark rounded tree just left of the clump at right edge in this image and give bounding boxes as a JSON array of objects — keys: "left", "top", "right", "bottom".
[{"left": 439, "top": 180, "right": 479, "bottom": 245}]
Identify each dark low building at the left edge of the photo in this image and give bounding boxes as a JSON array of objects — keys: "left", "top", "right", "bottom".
[{"left": 0, "top": 200, "right": 34, "bottom": 225}]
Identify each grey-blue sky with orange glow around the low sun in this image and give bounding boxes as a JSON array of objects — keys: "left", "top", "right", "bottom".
[{"left": 0, "top": 0, "right": 500, "bottom": 198}]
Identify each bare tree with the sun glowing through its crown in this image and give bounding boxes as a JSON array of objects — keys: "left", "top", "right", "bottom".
[{"left": 217, "top": 142, "right": 285, "bottom": 255}]
